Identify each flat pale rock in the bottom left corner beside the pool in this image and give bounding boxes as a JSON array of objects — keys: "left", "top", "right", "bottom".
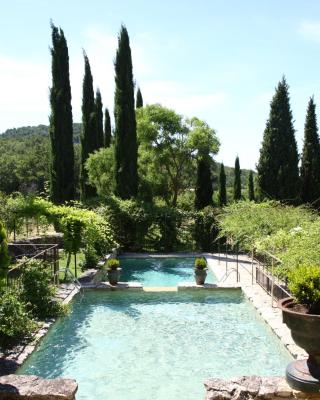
[{"left": 0, "top": 375, "right": 78, "bottom": 400}]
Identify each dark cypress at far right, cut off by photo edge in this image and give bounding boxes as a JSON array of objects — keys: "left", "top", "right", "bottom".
[{"left": 300, "top": 97, "right": 320, "bottom": 205}]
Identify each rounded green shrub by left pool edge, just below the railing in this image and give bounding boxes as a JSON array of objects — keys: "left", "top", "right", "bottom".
[{"left": 21, "top": 260, "right": 66, "bottom": 319}]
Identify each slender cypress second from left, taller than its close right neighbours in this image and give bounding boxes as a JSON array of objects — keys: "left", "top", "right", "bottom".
[{"left": 80, "top": 53, "right": 97, "bottom": 199}]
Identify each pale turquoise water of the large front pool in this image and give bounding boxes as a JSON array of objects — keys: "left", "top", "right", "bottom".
[{"left": 18, "top": 291, "right": 291, "bottom": 400}]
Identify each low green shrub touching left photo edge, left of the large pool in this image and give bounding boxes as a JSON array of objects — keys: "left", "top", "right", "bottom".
[{"left": 0, "top": 289, "right": 36, "bottom": 347}]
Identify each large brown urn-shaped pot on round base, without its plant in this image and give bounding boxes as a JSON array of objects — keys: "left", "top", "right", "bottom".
[{"left": 279, "top": 297, "right": 320, "bottom": 393}]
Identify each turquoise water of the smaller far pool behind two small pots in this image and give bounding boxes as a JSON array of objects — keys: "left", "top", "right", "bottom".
[{"left": 120, "top": 257, "right": 216, "bottom": 287}]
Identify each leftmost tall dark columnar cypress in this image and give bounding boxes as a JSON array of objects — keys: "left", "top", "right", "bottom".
[{"left": 49, "top": 23, "right": 75, "bottom": 204}]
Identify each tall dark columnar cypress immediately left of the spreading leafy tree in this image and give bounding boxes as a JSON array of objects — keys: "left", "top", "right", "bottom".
[{"left": 114, "top": 25, "right": 138, "bottom": 199}]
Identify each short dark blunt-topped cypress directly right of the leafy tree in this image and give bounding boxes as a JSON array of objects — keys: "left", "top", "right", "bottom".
[{"left": 195, "top": 154, "right": 213, "bottom": 210}]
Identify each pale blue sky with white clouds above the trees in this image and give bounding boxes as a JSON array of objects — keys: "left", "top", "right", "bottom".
[{"left": 0, "top": 0, "right": 320, "bottom": 168}]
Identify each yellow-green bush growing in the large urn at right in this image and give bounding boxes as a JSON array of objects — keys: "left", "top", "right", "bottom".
[{"left": 288, "top": 265, "right": 320, "bottom": 314}]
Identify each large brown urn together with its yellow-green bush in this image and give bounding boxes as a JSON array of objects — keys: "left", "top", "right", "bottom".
[{"left": 279, "top": 265, "right": 320, "bottom": 393}]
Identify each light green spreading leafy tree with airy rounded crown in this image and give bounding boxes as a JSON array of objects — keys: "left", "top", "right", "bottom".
[{"left": 137, "top": 104, "right": 219, "bottom": 207}]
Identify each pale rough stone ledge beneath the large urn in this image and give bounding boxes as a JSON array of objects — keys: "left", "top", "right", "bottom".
[{"left": 204, "top": 376, "right": 320, "bottom": 400}]
